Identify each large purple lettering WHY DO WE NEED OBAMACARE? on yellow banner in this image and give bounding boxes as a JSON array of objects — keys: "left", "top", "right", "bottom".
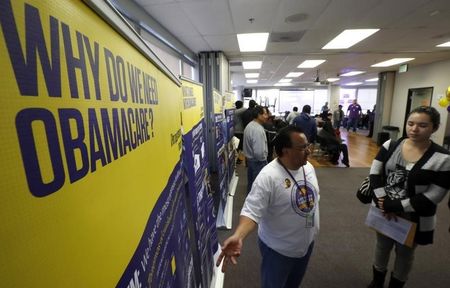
[{"left": 0, "top": 1, "right": 159, "bottom": 197}]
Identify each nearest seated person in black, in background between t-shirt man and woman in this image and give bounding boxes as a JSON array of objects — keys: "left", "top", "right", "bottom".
[{"left": 317, "top": 113, "right": 350, "bottom": 167}]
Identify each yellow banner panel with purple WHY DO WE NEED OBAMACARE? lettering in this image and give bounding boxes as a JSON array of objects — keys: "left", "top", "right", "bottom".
[{"left": 0, "top": 0, "right": 181, "bottom": 287}]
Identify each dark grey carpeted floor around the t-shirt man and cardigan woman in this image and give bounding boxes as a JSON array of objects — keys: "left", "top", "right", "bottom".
[{"left": 219, "top": 165, "right": 450, "bottom": 288}]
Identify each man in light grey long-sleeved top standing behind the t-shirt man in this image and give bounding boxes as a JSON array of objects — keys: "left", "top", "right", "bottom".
[{"left": 244, "top": 106, "right": 269, "bottom": 193}]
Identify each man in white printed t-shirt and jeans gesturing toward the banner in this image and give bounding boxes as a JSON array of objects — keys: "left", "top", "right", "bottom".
[{"left": 216, "top": 126, "right": 320, "bottom": 288}]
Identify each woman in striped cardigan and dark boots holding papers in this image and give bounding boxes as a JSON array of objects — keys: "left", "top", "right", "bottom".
[{"left": 368, "top": 106, "right": 450, "bottom": 288}]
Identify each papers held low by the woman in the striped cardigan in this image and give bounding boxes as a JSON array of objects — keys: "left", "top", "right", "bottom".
[{"left": 366, "top": 206, "right": 413, "bottom": 244}]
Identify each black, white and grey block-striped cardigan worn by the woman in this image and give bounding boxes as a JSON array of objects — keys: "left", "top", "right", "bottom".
[{"left": 370, "top": 138, "right": 450, "bottom": 245}]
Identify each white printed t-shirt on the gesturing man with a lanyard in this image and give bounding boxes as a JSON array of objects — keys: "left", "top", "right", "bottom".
[{"left": 241, "top": 159, "right": 320, "bottom": 258}]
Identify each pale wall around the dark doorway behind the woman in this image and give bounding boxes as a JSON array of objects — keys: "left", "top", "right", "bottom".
[{"left": 390, "top": 61, "right": 450, "bottom": 144}]
